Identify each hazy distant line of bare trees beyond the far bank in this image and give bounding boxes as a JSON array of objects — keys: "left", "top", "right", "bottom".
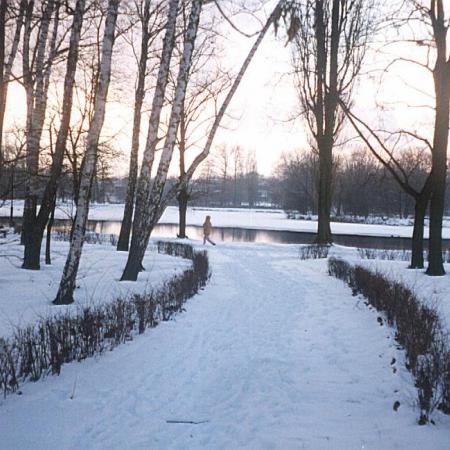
[{"left": 1, "top": 150, "right": 450, "bottom": 218}]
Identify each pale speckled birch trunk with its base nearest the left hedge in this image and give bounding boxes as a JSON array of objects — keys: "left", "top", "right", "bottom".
[{"left": 53, "top": 0, "right": 120, "bottom": 305}]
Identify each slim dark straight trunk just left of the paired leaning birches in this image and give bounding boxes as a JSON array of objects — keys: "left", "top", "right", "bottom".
[{"left": 117, "top": 0, "right": 150, "bottom": 252}]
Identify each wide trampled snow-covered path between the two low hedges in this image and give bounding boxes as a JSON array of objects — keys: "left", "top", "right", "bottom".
[{"left": 0, "top": 244, "right": 450, "bottom": 450}]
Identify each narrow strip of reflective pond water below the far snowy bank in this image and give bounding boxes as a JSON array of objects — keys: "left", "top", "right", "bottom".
[{"left": 0, "top": 217, "right": 450, "bottom": 250}]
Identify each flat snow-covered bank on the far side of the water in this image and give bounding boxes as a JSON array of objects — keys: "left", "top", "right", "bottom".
[{"left": 0, "top": 201, "right": 450, "bottom": 239}]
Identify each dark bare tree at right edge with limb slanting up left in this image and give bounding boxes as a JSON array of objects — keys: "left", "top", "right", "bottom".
[{"left": 340, "top": 0, "right": 450, "bottom": 276}]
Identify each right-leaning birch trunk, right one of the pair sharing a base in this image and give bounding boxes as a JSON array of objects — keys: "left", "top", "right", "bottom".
[{"left": 121, "top": 0, "right": 203, "bottom": 281}]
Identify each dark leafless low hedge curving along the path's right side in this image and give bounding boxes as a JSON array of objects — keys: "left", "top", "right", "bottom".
[{"left": 328, "top": 258, "right": 450, "bottom": 424}]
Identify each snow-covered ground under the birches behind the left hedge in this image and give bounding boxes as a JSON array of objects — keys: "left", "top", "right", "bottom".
[{"left": 0, "top": 235, "right": 190, "bottom": 338}]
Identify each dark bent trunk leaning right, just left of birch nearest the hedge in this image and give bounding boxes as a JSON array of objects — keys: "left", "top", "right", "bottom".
[{"left": 23, "top": 0, "right": 86, "bottom": 269}]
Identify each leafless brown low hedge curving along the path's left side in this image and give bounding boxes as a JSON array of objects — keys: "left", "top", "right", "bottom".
[{"left": 0, "top": 244, "right": 210, "bottom": 395}]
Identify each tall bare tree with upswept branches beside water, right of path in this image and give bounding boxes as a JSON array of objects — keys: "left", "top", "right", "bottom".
[{"left": 283, "top": 0, "right": 375, "bottom": 243}]
